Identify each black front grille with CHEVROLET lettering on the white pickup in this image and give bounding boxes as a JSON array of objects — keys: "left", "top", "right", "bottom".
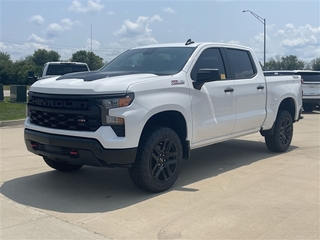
[{"left": 28, "top": 92, "right": 102, "bottom": 131}]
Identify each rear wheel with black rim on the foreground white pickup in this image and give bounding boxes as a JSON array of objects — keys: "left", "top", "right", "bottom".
[{"left": 265, "top": 110, "right": 293, "bottom": 152}]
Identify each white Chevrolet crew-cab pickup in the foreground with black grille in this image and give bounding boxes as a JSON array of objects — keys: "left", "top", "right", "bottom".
[{"left": 24, "top": 40, "right": 302, "bottom": 192}]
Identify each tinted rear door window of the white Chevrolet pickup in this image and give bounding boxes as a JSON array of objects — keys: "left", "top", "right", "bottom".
[{"left": 226, "top": 48, "right": 257, "bottom": 79}]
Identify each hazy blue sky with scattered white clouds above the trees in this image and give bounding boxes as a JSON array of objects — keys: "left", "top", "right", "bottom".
[{"left": 0, "top": 0, "right": 320, "bottom": 62}]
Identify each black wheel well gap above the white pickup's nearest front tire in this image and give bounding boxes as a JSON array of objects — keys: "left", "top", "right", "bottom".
[{"left": 140, "top": 111, "right": 190, "bottom": 158}]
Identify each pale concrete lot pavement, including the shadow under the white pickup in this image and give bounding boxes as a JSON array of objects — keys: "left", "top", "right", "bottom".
[{"left": 0, "top": 112, "right": 320, "bottom": 239}]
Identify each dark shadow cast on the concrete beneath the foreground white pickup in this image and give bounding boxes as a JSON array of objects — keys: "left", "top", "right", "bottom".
[{"left": 0, "top": 139, "right": 297, "bottom": 213}]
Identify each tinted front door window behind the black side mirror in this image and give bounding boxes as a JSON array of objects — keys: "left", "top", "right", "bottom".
[{"left": 191, "top": 48, "right": 227, "bottom": 81}]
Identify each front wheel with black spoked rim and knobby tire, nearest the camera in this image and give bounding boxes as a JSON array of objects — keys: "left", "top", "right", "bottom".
[{"left": 129, "top": 126, "right": 183, "bottom": 193}]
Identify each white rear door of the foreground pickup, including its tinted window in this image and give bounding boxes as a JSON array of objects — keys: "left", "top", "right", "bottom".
[{"left": 225, "top": 48, "right": 267, "bottom": 134}]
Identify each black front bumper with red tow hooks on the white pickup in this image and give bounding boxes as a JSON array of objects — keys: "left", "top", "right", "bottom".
[{"left": 24, "top": 129, "right": 137, "bottom": 167}]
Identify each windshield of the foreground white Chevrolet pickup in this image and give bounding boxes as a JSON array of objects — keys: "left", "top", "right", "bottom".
[{"left": 100, "top": 47, "right": 195, "bottom": 75}]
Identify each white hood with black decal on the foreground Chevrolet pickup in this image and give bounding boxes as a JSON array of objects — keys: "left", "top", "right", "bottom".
[{"left": 29, "top": 71, "right": 158, "bottom": 94}]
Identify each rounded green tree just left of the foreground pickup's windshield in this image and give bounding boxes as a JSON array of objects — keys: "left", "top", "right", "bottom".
[{"left": 70, "top": 50, "right": 104, "bottom": 71}]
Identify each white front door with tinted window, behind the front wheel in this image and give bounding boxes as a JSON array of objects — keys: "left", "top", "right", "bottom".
[{"left": 190, "top": 47, "right": 236, "bottom": 147}]
